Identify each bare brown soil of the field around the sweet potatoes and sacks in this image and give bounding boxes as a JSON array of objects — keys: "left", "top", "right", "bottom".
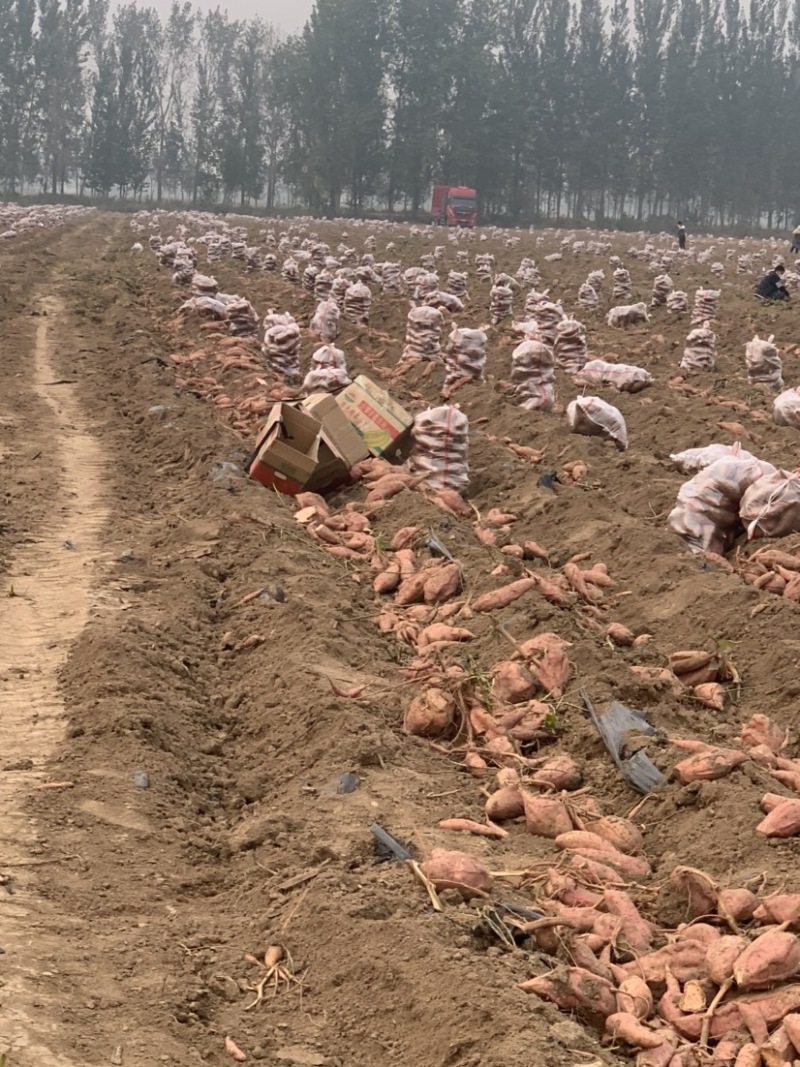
[{"left": 0, "top": 214, "right": 800, "bottom": 1067}]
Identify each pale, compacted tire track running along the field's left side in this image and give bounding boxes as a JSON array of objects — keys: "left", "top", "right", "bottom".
[{"left": 0, "top": 296, "right": 109, "bottom": 1067}]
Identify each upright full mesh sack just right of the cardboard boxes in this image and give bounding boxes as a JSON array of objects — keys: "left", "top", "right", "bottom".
[{"left": 409, "top": 404, "right": 469, "bottom": 493}]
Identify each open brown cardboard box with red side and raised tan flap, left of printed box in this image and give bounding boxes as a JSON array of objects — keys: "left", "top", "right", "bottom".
[{"left": 247, "top": 394, "right": 369, "bottom": 496}]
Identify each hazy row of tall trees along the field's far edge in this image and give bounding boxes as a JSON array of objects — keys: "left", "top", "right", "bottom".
[{"left": 0, "top": 0, "right": 800, "bottom": 228}]
